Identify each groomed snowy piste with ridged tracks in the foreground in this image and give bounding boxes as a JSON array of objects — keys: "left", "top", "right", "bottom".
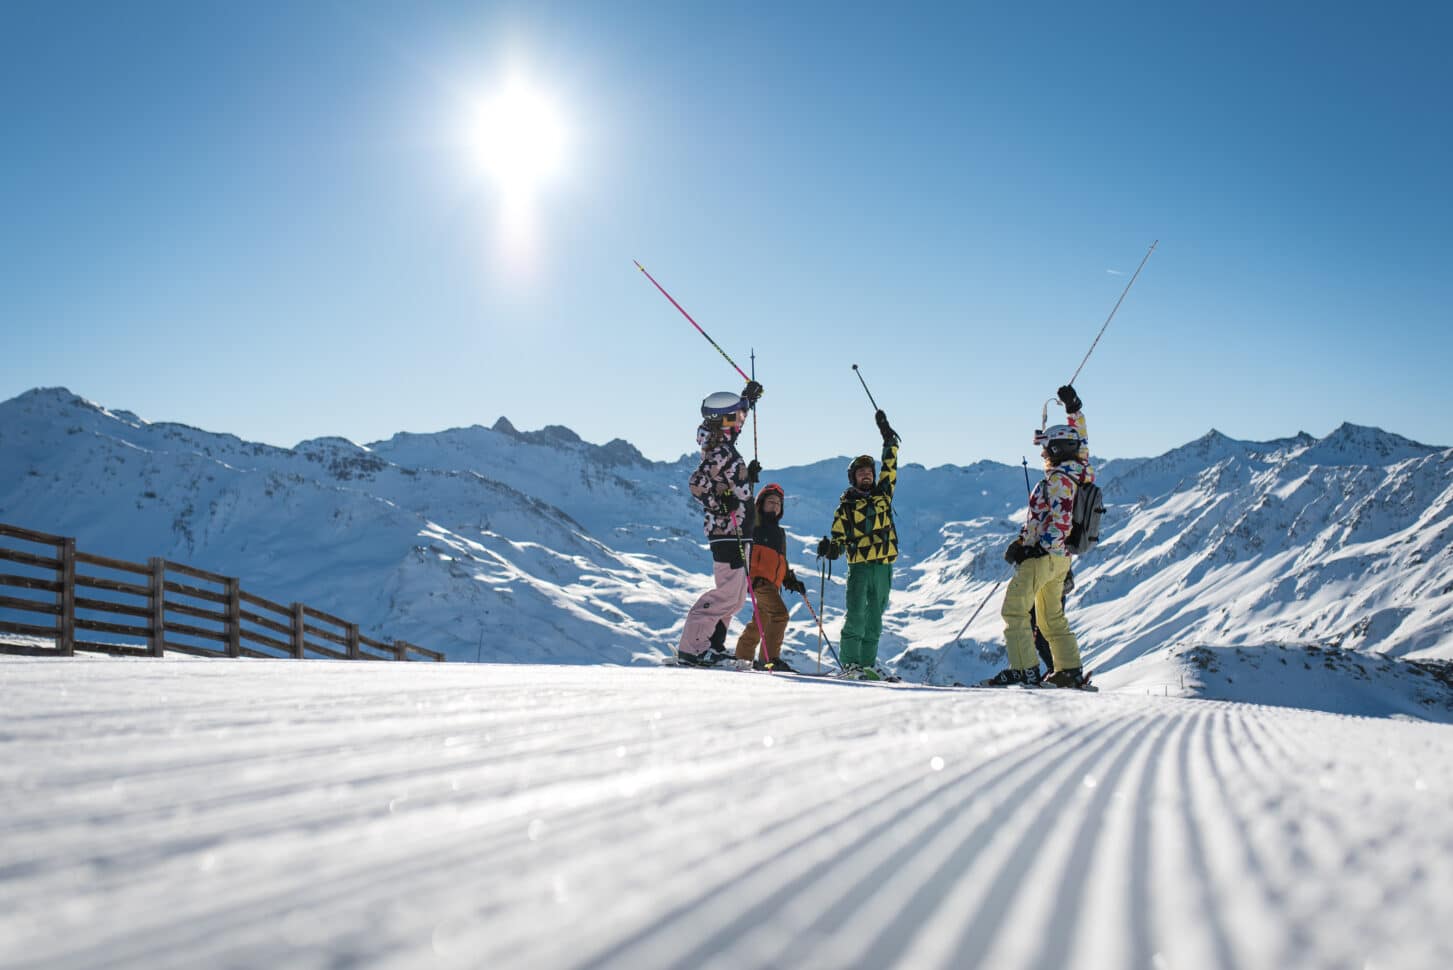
[{"left": 0, "top": 656, "right": 1453, "bottom": 970}]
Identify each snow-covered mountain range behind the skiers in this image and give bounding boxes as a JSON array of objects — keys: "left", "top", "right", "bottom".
[{"left": 0, "top": 389, "right": 1453, "bottom": 697}]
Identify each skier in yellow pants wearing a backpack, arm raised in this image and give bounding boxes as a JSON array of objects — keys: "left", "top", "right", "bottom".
[{"left": 984, "top": 385, "right": 1094, "bottom": 687}]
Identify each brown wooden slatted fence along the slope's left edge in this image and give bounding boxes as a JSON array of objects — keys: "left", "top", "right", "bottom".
[{"left": 0, "top": 523, "right": 445, "bottom": 661}]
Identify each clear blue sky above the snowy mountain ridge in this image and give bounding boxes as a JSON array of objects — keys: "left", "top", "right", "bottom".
[{"left": 0, "top": 1, "right": 1453, "bottom": 469}]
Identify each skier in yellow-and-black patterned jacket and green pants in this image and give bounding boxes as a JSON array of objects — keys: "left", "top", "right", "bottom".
[{"left": 818, "top": 411, "right": 898, "bottom": 680}]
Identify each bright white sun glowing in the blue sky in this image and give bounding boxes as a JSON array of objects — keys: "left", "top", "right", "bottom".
[{"left": 472, "top": 78, "right": 565, "bottom": 203}]
